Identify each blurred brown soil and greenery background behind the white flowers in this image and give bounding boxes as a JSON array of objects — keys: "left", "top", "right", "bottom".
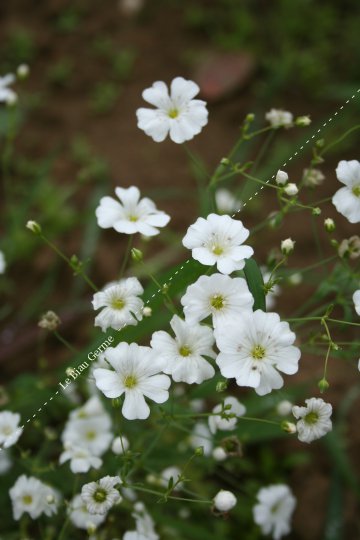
[{"left": 0, "top": 0, "right": 360, "bottom": 540}]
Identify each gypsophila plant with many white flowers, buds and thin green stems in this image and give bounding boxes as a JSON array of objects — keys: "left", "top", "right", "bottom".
[{"left": 0, "top": 70, "right": 360, "bottom": 540}]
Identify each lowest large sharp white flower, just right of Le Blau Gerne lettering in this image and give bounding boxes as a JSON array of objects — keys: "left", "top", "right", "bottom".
[{"left": 94, "top": 343, "right": 171, "bottom": 420}]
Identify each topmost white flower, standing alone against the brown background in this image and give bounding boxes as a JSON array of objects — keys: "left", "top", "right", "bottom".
[{"left": 136, "top": 77, "right": 208, "bottom": 144}]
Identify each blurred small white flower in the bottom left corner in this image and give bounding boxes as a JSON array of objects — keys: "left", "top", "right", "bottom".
[{"left": 9, "top": 474, "right": 60, "bottom": 520}]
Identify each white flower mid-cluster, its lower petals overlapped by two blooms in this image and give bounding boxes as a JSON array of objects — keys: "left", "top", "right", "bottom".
[{"left": 181, "top": 274, "right": 254, "bottom": 327}]
